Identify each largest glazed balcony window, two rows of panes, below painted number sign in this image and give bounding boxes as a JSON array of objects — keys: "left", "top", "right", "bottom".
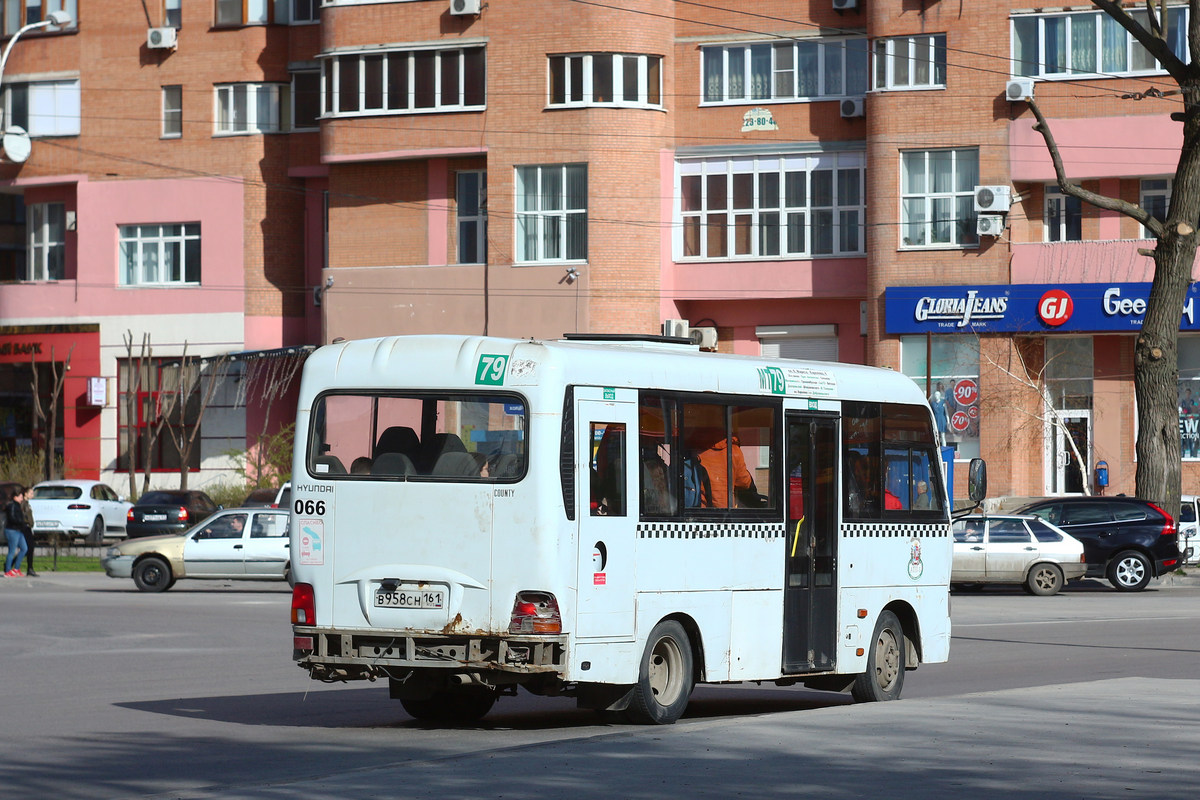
[{"left": 677, "top": 152, "right": 865, "bottom": 260}]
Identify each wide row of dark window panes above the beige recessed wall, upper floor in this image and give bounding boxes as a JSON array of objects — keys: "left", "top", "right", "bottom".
[{"left": 322, "top": 47, "right": 486, "bottom": 116}]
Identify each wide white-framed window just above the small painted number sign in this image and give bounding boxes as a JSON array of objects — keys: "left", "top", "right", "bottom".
[{"left": 701, "top": 37, "right": 868, "bottom": 103}]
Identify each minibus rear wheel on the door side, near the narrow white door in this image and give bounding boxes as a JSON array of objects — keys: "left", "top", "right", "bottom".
[{"left": 625, "top": 620, "right": 695, "bottom": 724}]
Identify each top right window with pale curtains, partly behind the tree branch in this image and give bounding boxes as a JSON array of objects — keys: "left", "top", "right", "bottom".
[{"left": 1012, "top": 5, "right": 1188, "bottom": 78}]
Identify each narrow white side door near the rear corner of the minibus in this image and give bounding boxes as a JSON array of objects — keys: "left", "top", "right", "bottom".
[{"left": 575, "top": 386, "right": 637, "bottom": 638}]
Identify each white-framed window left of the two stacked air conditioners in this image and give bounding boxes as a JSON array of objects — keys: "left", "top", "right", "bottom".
[{"left": 900, "top": 148, "right": 979, "bottom": 247}]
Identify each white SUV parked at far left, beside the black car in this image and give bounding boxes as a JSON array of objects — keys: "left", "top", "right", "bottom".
[{"left": 29, "top": 480, "right": 133, "bottom": 545}]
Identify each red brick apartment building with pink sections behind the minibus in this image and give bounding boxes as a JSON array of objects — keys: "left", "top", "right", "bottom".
[{"left": 0, "top": 0, "right": 1200, "bottom": 503}]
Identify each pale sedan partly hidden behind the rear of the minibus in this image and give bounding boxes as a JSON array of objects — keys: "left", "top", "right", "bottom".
[{"left": 100, "top": 507, "right": 292, "bottom": 591}]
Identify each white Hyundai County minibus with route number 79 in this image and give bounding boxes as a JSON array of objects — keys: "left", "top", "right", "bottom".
[{"left": 292, "top": 335, "right": 985, "bottom": 723}]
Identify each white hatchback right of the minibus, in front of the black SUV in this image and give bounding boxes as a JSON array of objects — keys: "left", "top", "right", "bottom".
[{"left": 950, "top": 515, "right": 1087, "bottom": 596}]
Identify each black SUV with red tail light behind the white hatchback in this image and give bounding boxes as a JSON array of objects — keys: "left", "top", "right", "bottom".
[{"left": 1016, "top": 497, "right": 1182, "bottom": 591}]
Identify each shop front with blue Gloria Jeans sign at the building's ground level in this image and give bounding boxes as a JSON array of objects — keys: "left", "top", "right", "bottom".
[{"left": 884, "top": 283, "right": 1200, "bottom": 494}]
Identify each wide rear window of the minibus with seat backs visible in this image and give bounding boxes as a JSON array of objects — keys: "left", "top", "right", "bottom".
[{"left": 307, "top": 392, "right": 526, "bottom": 482}]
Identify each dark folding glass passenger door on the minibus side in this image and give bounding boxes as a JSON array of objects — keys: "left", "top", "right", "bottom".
[{"left": 782, "top": 413, "right": 838, "bottom": 673}]
